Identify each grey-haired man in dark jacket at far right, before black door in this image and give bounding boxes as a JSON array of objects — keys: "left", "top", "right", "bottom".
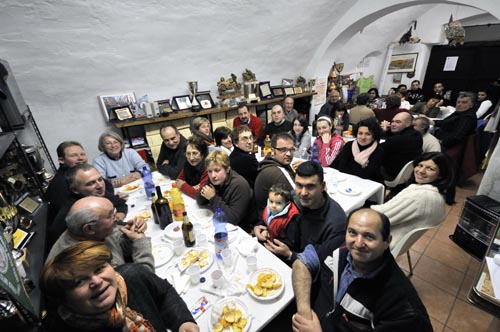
[{"left": 431, "top": 92, "right": 477, "bottom": 151}]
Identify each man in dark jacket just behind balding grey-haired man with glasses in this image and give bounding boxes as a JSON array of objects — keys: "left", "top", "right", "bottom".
[{"left": 47, "top": 164, "right": 128, "bottom": 248}]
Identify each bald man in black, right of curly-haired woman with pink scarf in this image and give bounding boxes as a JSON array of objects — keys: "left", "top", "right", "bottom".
[{"left": 380, "top": 112, "right": 423, "bottom": 180}]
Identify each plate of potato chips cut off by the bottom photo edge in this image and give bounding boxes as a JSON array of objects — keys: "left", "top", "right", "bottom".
[{"left": 210, "top": 297, "right": 251, "bottom": 332}]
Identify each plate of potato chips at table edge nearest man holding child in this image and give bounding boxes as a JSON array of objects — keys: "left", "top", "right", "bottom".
[{"left": 247, "top": 268, "right": 285, "bottom": 301}]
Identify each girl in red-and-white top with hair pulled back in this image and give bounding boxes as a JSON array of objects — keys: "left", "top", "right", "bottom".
[{"left": 314, "top": 116, "right": 344, "bottom": 167}]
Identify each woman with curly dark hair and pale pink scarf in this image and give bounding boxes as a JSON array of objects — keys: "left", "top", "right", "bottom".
[{"left": 332, "top": 118, "right": 383, "bottom": 182}]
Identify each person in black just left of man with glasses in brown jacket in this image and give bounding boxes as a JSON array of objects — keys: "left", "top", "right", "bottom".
[{"left": 229, "top": 125, "right": 259, "bottom": 189}]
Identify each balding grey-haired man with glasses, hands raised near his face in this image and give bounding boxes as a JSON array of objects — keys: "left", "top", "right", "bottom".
[{"left": 47, "top": 196, "right": 155, "bottom": 272}]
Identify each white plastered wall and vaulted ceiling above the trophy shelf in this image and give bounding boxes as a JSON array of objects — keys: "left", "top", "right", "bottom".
[{"left": 0, "top": 0, "right": 500, "bottom": 166}]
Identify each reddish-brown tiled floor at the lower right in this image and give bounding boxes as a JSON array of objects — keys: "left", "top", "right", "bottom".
[{"left": 398, "top": 174, "right": 500, "bottom": 332}]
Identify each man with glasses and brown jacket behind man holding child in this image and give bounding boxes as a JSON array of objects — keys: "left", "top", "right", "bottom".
[{"left": 254, "top": 133, "right": 295, "bottom": 219}]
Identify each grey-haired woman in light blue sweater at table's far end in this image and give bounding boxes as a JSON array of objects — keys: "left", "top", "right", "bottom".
[{"left": 93, "top": 131, "right": 148, "bottom": 187}]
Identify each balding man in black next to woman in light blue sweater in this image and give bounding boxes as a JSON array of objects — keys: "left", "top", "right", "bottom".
[{"left": 156, "top": 125, "right": 187, "bottom": 179}]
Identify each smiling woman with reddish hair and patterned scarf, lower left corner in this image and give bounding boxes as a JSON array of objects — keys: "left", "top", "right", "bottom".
[{"left": 40, "top": 241, "right": 200, "bottom": 332}]
